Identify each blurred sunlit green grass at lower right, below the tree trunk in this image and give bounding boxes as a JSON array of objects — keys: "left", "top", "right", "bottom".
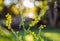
[{"left": 42, "top": 28, "right": 60, "bottom": 41}]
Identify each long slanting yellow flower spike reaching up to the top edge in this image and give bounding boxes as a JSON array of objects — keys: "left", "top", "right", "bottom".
[{"left": 29, "top": 0, "right": 48, "bottom": 27}]
